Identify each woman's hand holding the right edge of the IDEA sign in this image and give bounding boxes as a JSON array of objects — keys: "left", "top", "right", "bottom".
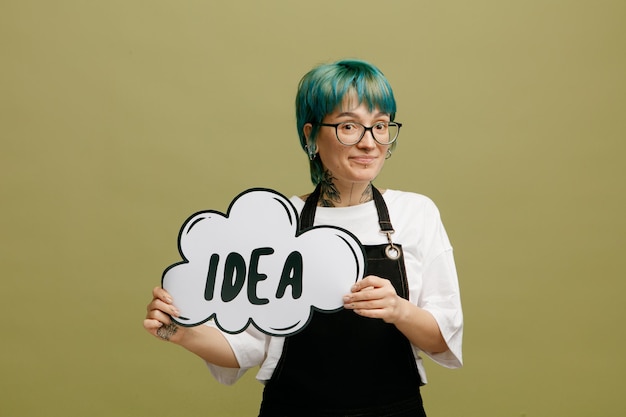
[{"left": 343, "top": 275, "right": 406, "bottom": 323}]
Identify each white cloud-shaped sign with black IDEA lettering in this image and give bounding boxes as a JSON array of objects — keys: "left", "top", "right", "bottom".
[{"left": 162, "top": 188, "right": 366, "bottom": 336}]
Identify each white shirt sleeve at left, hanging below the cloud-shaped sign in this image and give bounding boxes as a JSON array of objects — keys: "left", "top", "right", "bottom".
[{"left": 206, "top": 321, "right": 269, "bottom": 385}]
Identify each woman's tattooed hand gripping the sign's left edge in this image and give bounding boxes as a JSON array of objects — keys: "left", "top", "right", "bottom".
[{"left": 143, "top": 287, "right": 186, "bottom": 343}]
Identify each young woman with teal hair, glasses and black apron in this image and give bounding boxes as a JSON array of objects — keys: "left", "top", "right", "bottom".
[{"left": 144, "top": 60, "right": 463, "bottom": 417}]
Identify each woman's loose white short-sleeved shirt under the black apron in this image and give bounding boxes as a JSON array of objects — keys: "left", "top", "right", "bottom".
[{"left": 206, "top": 189, "right": 463, "bottom": 385}]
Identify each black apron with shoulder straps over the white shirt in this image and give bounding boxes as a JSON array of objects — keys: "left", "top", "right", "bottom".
[{"left": 259, "top": 186, "right": 426, "bottom": 417}]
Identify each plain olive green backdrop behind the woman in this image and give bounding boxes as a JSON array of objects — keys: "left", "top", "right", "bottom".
[{"left": 0, "top": 0, "right": 626, "bottom": 417}]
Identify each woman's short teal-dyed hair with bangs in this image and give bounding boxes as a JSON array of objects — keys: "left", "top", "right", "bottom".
[{"left": 296, "top": 60, "right": 396, "bottom": 185}]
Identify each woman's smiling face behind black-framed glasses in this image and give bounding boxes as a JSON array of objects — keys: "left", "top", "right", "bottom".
[{"left": 304, "top": 98, "right": 390, "bottom": 187}]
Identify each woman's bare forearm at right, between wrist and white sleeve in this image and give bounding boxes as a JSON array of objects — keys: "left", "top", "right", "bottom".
[{"left": 393, "top": 298, "right": 448, "bottom": 353}]
